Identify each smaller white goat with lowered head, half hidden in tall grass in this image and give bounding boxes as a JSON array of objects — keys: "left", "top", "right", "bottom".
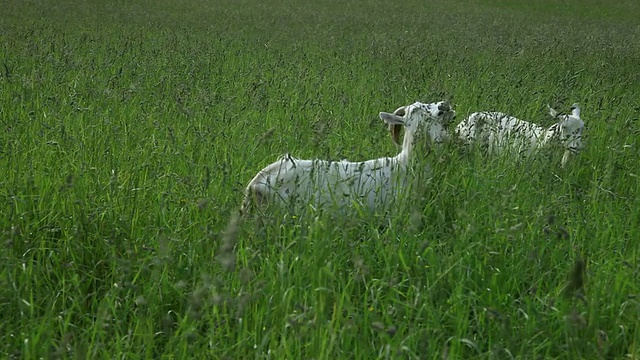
[{"left": 455, "top": 104, "right": 584, "bottom": 167}]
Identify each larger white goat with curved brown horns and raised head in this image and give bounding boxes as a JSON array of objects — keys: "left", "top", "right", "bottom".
[{"left": 241, "top": 101, "right": 455, "bottom": 213}]
